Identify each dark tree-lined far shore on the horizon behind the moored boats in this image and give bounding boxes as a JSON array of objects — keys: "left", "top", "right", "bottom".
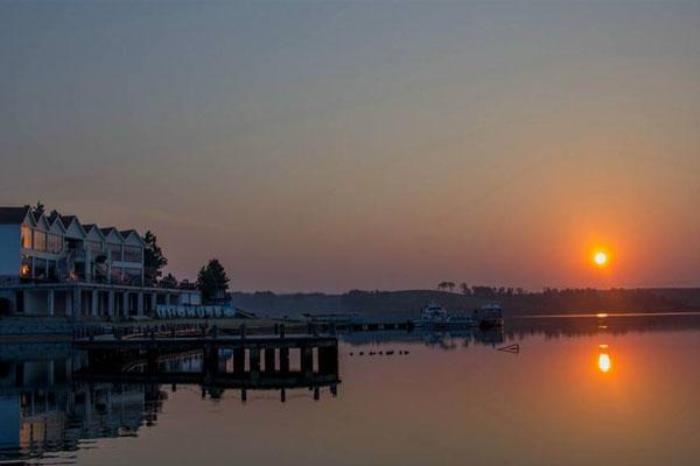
[{"left": 232, "top": 287, "right": 700, "bottom": 318}]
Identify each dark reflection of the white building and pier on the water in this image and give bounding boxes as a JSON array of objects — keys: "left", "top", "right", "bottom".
[{"left": 0, "top": 340, "right": 340, "bottom": 464}]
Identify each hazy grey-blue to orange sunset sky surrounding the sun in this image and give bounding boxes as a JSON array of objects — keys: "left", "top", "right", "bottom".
[{"left": 0, "top": 1, "right": 700, "bottom": 292}]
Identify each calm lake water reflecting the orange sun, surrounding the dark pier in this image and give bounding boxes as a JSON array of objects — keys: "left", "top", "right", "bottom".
[{"left": 0, "top": 315, "right": 700, "bottom": 466}]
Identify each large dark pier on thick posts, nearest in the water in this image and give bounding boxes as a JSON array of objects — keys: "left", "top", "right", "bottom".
[{"left": 73, "top": 335, "right": 340, "bottom": 401}]
